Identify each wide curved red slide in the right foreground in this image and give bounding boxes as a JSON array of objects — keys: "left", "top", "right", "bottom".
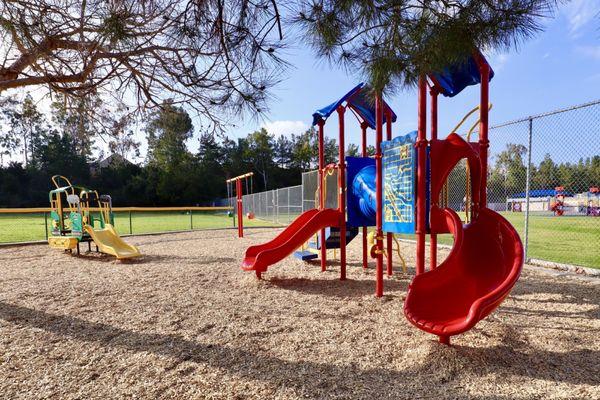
[{"left": 404, "top": 208, "right": 523, "bottom": 343}]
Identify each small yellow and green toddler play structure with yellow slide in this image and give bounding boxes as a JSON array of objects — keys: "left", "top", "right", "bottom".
[{"left": 48, "top": 175, "right": 141, "bottom": 260}]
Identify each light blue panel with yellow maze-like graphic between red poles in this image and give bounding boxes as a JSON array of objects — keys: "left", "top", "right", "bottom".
[{"left": 381, "top": 131, "right": 417, "bottom": 233}]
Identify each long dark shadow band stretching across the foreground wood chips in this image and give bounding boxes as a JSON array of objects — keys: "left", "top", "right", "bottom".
[{"left": 0, "top": 302, "right": 600, "bottom": 399}]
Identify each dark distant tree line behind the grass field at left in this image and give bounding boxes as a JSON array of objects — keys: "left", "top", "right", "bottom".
[{"left": 0, "top": 96, "right": 346, "bottom": 207}]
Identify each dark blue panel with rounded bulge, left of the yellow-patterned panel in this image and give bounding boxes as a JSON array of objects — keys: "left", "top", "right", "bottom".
[{"left": 346, "top": 157, "right": 377, "bottom": 227}]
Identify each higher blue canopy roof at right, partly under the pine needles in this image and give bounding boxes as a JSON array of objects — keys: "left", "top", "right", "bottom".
[{"left": 430, "top": 54, "right": 494, "bottom": 97}]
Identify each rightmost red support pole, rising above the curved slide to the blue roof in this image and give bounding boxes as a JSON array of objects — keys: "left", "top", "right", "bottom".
[{"left": 473, "top": 61, "right": 490, "bottom": 212}]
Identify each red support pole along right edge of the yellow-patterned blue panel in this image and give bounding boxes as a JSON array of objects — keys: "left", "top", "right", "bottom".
[{"left": 416, "top": 77, "right": 427, "bottom": 275}]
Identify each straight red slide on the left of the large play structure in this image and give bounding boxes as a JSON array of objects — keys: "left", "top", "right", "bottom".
[{"left": 242, "top": 208, "right": 343, "bottom": 277}]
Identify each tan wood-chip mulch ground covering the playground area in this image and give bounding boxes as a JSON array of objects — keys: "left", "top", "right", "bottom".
[{"left": 0, "top": 229, "right": 600, "bottom": 399}]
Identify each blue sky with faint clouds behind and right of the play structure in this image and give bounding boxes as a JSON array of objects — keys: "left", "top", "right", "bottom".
[{"left": 228, "top": 0, "right": 600, "bottom": 164}]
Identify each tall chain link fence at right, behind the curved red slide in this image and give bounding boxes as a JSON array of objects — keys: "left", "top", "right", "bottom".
[{"left": 448, "top": 101, "right": 600, "bottom": 268}]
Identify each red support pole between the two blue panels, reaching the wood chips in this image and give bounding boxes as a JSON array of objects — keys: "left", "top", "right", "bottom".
[{"left": 375, "top": 94, "right": 383, "bottom": 297}]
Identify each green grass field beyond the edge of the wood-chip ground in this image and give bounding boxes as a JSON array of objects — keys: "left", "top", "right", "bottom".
[{"left": 0, "top": 212, "right": 600, "bottom": 268}]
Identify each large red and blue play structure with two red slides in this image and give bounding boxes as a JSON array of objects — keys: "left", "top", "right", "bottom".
[{"left": 242, "top": 52, "right": 523, "bottom": 344}]
